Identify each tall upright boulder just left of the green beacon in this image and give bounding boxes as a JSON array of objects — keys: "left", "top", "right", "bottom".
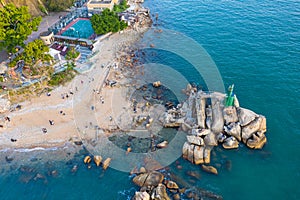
[{"left": 211, "top": 98, "right": 224, "bottom": 133}]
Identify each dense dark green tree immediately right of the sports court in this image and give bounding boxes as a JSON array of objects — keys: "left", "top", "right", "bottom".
[{"left": 91, "top": 9, "right": 127, "bottom": 35}]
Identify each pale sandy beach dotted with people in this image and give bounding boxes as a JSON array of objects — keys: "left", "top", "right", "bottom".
[{"left": 0, "top": 15, "right": 147, "bottom": 149}]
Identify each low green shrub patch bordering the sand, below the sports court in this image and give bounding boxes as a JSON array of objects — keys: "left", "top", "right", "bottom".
[{"left": 48, "top": 62, "right": 77, "bottom": 86}]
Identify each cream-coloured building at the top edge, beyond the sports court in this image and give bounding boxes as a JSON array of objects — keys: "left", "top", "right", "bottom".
[{"left": 86, "top": 0, "right": 119, "bottom": 13}]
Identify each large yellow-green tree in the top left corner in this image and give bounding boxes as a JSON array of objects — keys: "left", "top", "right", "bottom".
[{"left": 0, "top": 4, "right": 42, "bottom": 52}]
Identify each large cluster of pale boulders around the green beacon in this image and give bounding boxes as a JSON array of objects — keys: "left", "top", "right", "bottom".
[{"left": 164, "top": 85, "right": 267, "bottom": 170}]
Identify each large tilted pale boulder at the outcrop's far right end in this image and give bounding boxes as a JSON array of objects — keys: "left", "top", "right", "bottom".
[{"left": 242, "top": 116, "right": 264, "bottom": 143}]
